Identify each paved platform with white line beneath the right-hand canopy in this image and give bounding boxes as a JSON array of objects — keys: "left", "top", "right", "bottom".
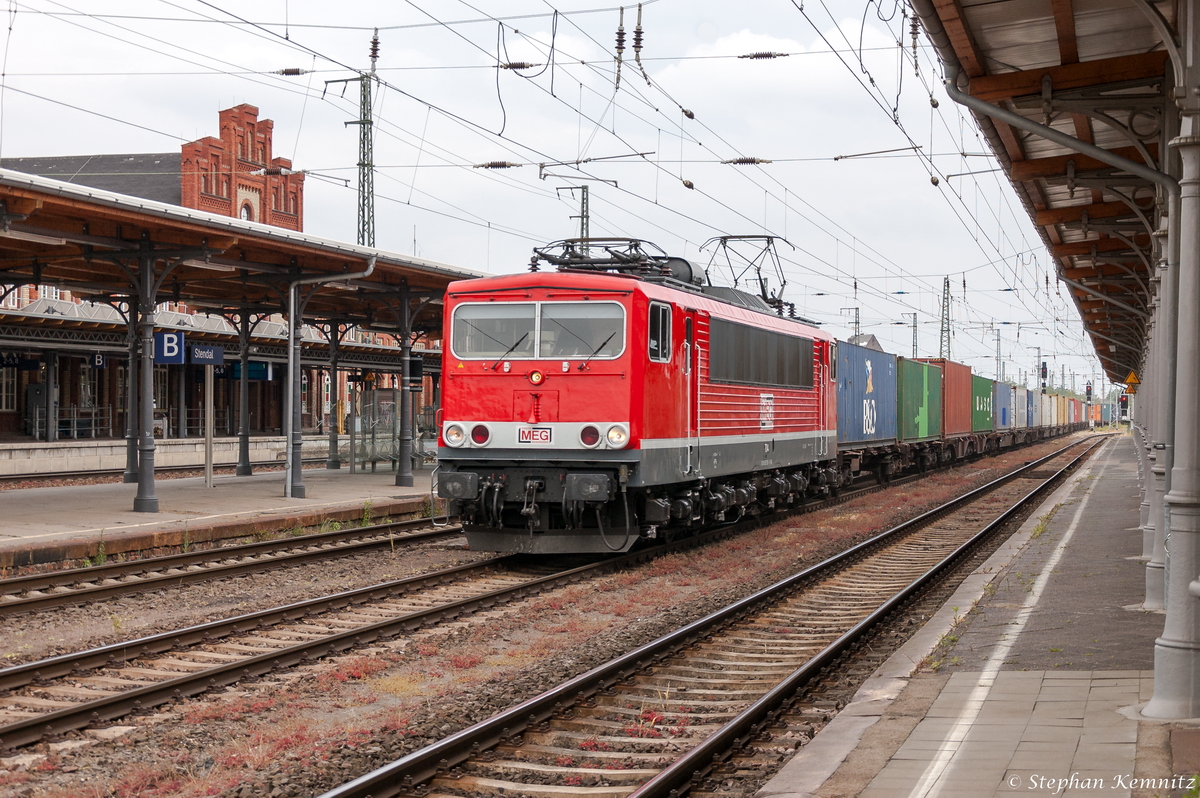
[{"left": 758, "top": 436, "right": 1200, "bottom": 798}]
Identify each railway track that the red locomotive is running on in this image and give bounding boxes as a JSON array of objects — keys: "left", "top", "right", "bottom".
[{"left": 0, "top": 432, "right": 1094, "bottom": 750}]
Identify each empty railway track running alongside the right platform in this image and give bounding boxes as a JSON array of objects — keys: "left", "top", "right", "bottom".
[{"left": 323, "top": 442, "right": 1098, "bottom": 798}]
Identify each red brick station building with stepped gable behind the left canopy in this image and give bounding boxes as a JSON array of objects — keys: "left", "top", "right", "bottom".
[{"left": 0, "top": 103, "right": 433, "bottom": 442}]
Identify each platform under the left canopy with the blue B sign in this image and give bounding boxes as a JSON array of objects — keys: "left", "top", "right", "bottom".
[{"left": 0, "top": 463, "right": 432, "bottom": 576}]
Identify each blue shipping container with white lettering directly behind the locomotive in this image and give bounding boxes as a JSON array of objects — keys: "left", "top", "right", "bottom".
[{"left": 838, "top": 341, "right": 896, "bottom": 448}]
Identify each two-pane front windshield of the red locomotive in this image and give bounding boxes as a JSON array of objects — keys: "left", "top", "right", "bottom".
[{"left": 451, "top": 302, "right": 625, "bottom": 360}]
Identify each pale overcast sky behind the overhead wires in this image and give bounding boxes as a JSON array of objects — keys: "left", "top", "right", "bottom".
[{"left": 0, "top": 0, "right": 1100, "bottom": 391}]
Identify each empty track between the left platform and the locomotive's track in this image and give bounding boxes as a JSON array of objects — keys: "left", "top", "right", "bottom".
[{"left": 0, "top": 518, "right": 461, "bottom": 618}]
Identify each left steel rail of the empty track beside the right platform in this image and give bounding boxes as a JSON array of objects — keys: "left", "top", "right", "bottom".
[{"left": 319, "top": 440, "right": 1094, "bottom": 798}]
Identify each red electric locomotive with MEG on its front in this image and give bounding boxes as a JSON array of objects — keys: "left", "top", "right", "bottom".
[{"left": 437, "top": 239, "right": 844, "bottom": 553}]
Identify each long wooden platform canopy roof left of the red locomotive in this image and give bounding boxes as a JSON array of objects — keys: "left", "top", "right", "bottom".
[{"left": 0, "top": 169, "right": 481, "bottom": 332}]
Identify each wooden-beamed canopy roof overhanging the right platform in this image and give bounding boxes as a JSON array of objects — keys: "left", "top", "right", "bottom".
[{"left": 913, "top": 0, "right": 1178, "bottom": 382}]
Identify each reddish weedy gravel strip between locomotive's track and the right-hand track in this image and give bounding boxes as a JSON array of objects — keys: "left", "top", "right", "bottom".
[{"left": 0, "top": 436, "right": 1089, "bottom": 798}]
